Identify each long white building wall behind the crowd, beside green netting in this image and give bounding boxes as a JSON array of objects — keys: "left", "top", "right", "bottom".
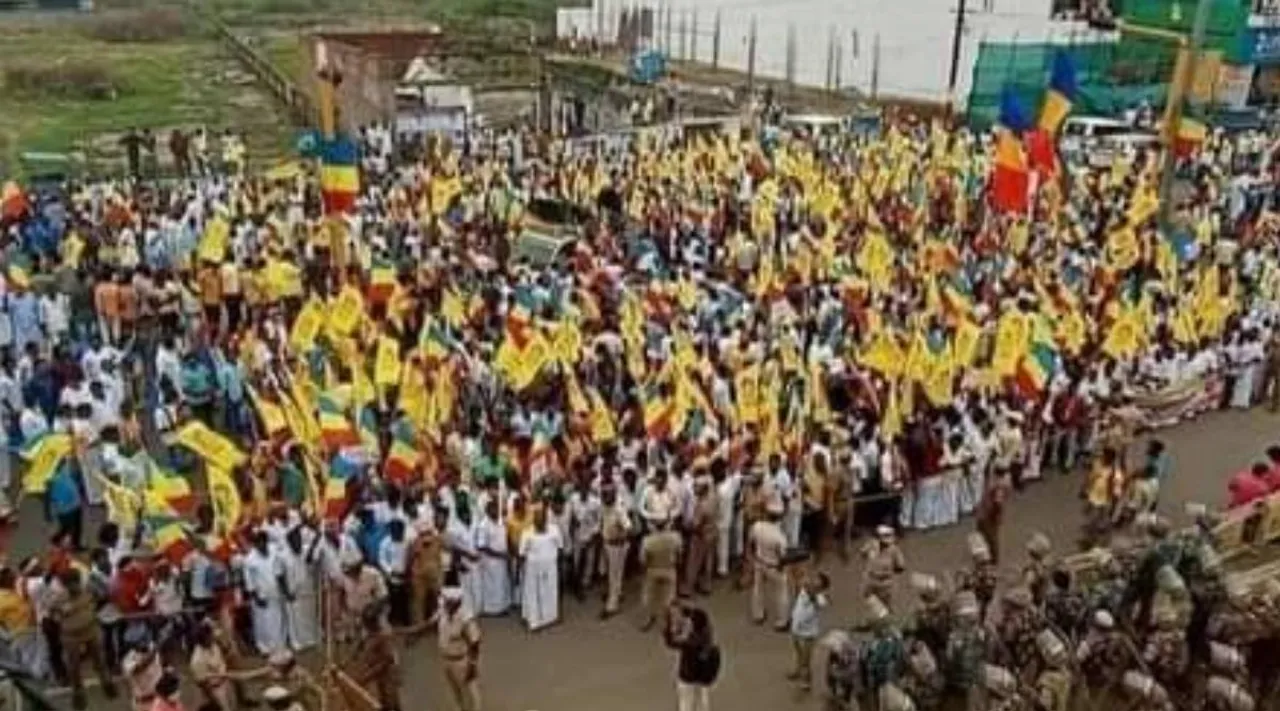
[{"left": 557, "top": 0, "right": 1096, "bottom": 104}]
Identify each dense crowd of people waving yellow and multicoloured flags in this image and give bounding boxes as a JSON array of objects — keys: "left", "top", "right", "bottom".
[{"left": 0, "top": 98, "right": 1280, "bottom": 711}]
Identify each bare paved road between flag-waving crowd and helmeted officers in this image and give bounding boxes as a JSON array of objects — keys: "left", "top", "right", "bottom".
[{"left": 12, "top": 410, "right": 1280, "bottom": 711}]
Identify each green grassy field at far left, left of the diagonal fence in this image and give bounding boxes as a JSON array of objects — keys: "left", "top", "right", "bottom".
[{"left": 0, "top": 23, "right": 293, "bottom": 178}]
